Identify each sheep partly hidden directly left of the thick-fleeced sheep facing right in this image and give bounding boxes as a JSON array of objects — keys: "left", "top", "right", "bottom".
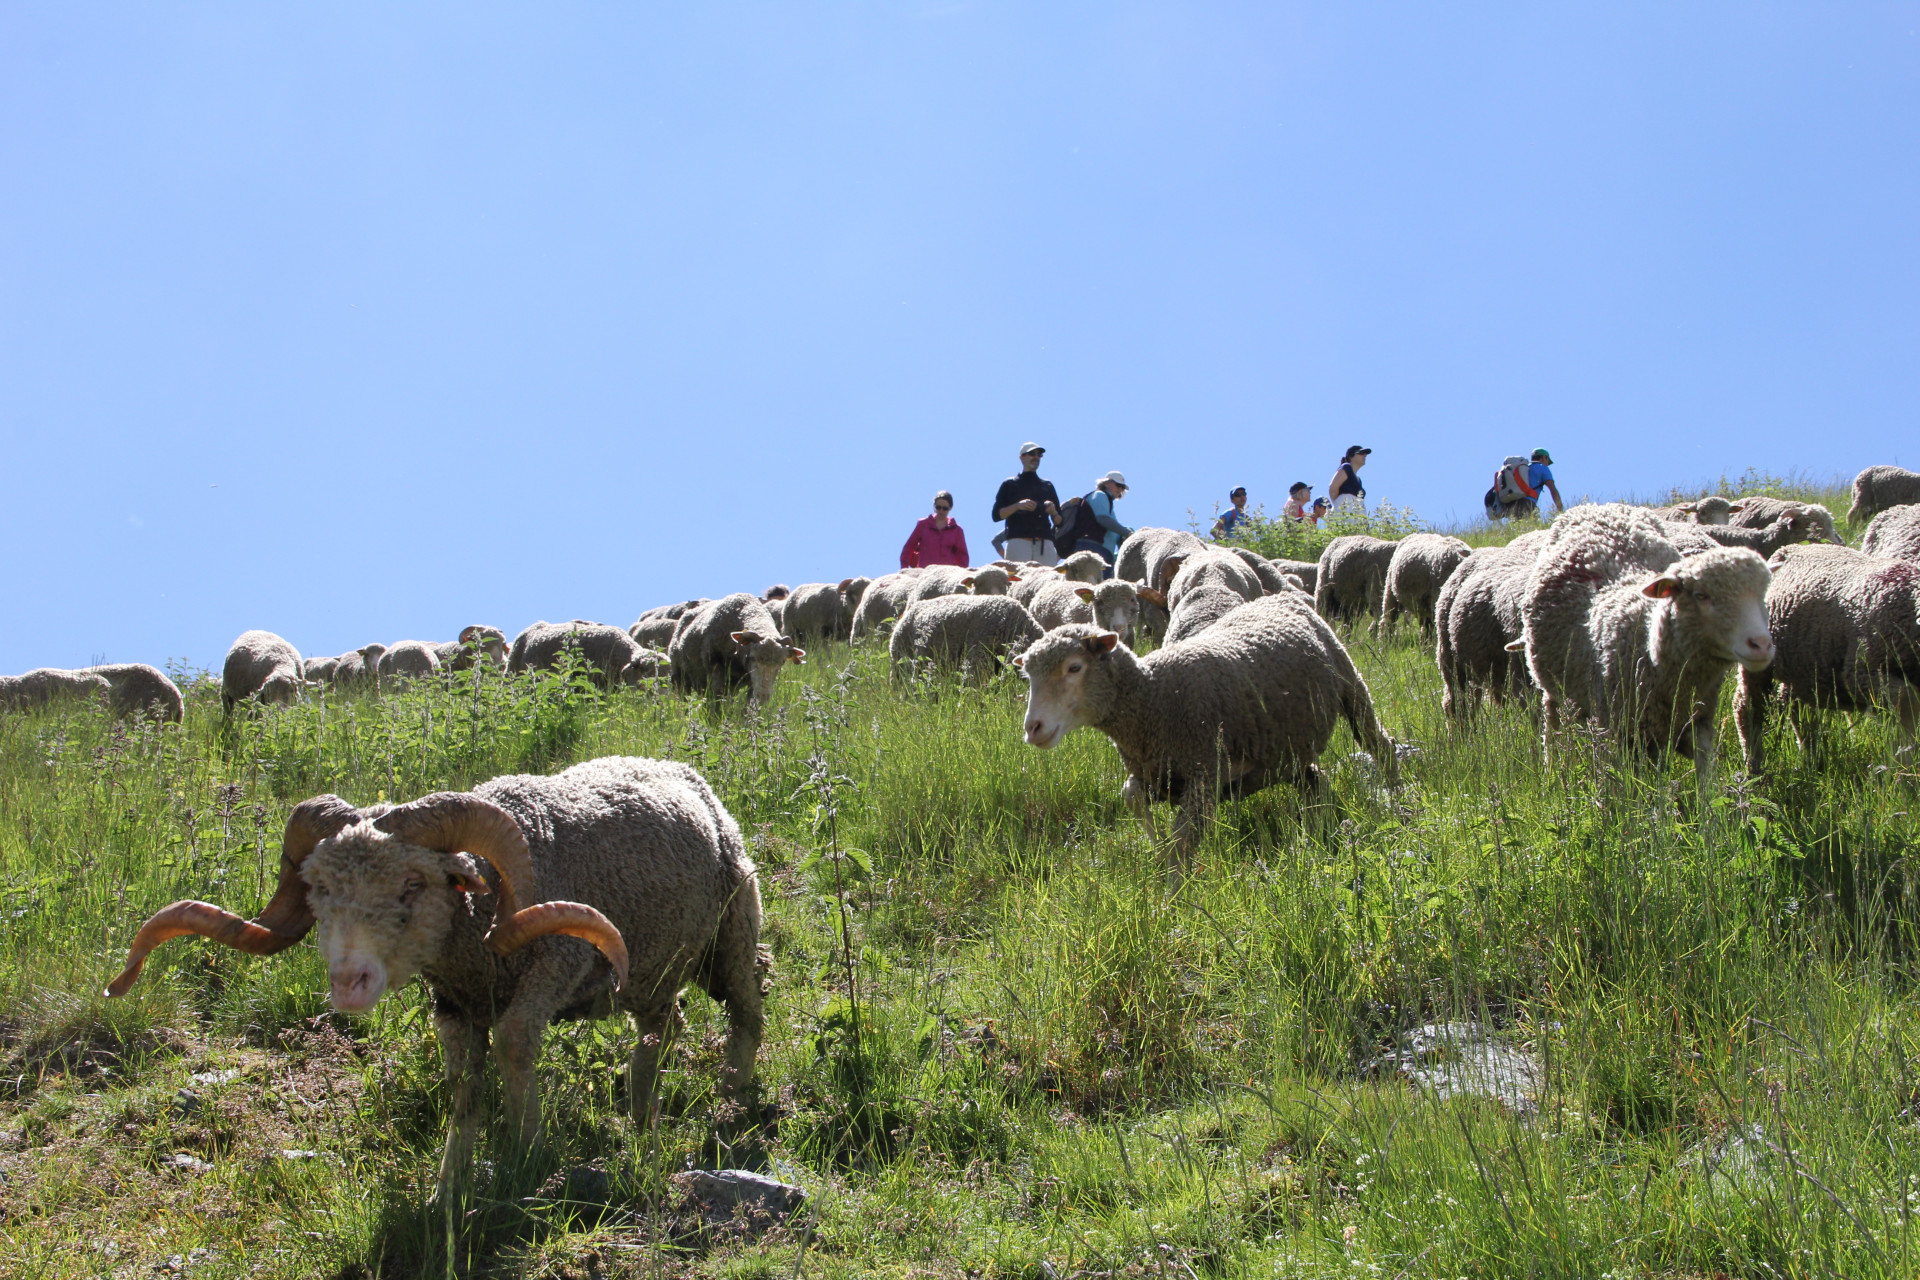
[{"left": 1434, "top": 530, "right": 1546, "bottom": 720}]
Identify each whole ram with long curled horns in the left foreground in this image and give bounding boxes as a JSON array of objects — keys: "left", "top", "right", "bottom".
[{"left": 108, "top": 756, "right": 768, "bottom": 1201}]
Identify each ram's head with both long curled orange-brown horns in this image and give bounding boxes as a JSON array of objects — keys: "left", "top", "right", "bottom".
[{"left": 108, "top": 793, "right": 626, "bottom": 1013}]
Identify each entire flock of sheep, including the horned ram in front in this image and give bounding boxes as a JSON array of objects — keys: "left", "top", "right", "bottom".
[{"left": 0, "top": 466, "right": 1920, "bottom": 1192}]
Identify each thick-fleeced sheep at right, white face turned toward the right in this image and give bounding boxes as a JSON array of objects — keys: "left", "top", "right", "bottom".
[{"left": 1513, "top": 503, "right": 1774, "bottom": 779}]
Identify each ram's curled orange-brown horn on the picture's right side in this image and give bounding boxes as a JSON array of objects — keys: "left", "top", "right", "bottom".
[{"left": 374, "top": 791, "right": 626, "bottom": 990}]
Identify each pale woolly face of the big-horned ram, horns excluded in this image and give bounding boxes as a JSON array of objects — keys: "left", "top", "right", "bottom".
[{"left": 300, "top": 821, "right": 490, "bottom": 1013}]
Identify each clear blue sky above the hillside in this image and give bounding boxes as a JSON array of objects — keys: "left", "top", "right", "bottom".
[{"left": 0, "top": 0, "right": 1920, "bottom": 672}]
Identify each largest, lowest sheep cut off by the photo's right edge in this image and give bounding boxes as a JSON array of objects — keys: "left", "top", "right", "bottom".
[{"left": 1734, "top": 545, "right": 1920, "bottom": 773}]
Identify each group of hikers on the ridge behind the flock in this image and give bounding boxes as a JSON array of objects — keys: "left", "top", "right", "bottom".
[{"left": 900, "top": 439, "right": 1565, "bottom": 578}]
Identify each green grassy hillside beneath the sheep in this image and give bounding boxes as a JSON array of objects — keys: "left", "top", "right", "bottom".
[{"left": 0, "top": 475, "right": 1920, "bottom": 1280}]
